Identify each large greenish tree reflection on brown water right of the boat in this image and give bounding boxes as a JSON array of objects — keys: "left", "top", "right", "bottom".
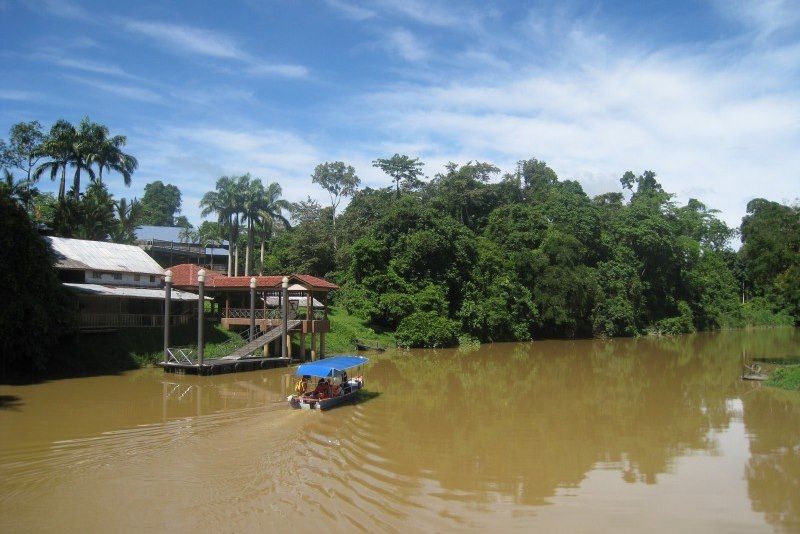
[{"left": 302, "top": 333, "right": 764, "bottom": 510}]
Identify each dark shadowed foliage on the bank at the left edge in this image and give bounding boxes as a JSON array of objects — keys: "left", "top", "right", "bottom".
[{"left": 0, "top": 191, "right": 72, "bottom": 384}]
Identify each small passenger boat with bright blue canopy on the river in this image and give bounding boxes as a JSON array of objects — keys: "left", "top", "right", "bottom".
[{"left": 286, "top": 356, "right": 369, "bottom": 410}]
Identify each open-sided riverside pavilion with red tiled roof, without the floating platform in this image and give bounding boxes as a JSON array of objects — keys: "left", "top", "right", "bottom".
[{"left": 170, "top": 263, "right": 339, "bottom": 359}]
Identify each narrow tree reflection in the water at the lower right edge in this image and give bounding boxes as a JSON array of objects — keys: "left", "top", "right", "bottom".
[{"left": 743, "top": 388, "right": 800, "bottom": 531}]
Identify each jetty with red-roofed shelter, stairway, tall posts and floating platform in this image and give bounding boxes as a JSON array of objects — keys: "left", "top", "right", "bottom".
[{"left": 159, "top": 264, "right": 338, "bottom": 375}]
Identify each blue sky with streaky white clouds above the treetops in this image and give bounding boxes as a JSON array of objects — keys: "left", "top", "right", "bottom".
[{"left": 0, "top": 0, "right": 800, "bottom": 226}]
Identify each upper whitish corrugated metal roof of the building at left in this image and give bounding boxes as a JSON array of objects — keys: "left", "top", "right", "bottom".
[{"left": 45, "top": 237, "right": 164, "bottom": 275}]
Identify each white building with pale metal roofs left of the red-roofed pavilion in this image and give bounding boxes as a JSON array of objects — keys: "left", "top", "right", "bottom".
[{"left": 45, "top": 237, "right": 197, "bottom": 331}]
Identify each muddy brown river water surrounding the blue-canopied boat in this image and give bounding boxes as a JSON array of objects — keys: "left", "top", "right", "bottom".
[{"left": 0, "top": 329, "right": 800, "bottom": 533}]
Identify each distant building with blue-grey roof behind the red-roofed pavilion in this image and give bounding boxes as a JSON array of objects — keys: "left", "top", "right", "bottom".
[{"left": 135, "top": 226, "right": 228, "bottom": 270}]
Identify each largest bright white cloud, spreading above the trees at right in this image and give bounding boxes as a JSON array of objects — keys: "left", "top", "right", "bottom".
[{"left": 365, "top": 31, "right": 800, "bottom": 225}]
